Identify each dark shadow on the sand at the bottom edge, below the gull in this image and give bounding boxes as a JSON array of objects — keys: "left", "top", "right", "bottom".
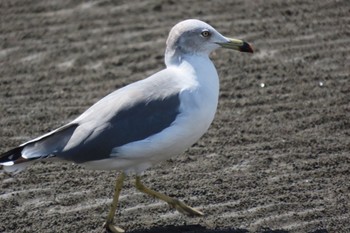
[{"left": 127, "top": 225, "right": 289, "bottom": 233}]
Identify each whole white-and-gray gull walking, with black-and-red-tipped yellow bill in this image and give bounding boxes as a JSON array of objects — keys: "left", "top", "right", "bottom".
[{"left": 0, "top": 19, "right": 253, "bottom": 233}]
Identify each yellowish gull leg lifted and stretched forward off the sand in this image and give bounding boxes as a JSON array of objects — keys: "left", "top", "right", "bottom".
[{"left": 135, "top": 176, "right": 204, "bottom": 216}]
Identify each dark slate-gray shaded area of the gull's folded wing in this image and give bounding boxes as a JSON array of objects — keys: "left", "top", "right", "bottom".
[{"left": 56, "top": 94, "right": 180, "bottom": 163}]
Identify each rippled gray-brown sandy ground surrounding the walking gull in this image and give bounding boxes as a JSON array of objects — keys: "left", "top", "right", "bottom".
[{"left": 0, "top": 0, "right": 350, "bottom": 233}]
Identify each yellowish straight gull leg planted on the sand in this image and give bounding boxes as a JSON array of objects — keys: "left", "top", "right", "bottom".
[{"left": 103, "top": 172, "right": 125, "bottom": 233}]
